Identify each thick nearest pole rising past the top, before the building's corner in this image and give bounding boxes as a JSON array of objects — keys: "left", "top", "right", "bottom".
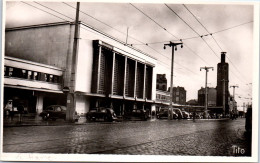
[{"left": 66, "top": 2, "right": 80, "bottom": 121}]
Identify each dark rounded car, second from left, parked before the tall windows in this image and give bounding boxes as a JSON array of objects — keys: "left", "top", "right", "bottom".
[{"left": 87, "top": 107, "right": 117, "bottom": 122}]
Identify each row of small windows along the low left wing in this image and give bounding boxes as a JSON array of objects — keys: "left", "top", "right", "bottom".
[{"left": 4, "top": 66, "right": 61, "bottom": 83}]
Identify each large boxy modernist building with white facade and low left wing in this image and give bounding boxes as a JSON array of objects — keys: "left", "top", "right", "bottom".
[{"left": 4, "top": 22, "right": 156, "bottom": 120}]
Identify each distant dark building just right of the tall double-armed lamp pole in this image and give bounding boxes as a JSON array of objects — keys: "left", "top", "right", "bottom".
[{"left": 168, "top": 86, "right": 186, "bottom": 105}]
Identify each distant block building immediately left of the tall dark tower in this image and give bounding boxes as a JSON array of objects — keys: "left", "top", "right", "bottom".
[{"left": 198, "top": 87, "right": 217, "bottom": 106}]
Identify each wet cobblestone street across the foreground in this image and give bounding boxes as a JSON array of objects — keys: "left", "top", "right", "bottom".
[{"left": 3, "top": 118, "right": 250, "bottom": 156}]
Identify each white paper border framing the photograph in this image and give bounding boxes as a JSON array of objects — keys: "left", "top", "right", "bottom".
[{"left": 0, "top": 0, "right": 260, "bottom": 162}]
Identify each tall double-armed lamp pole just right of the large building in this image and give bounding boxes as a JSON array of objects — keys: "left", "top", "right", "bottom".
[{"left": 163, "top": 41, "right": 183, "bottom": 120}]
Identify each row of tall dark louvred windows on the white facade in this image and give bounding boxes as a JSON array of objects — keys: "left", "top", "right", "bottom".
[{"left": 92, "top": 44, "right": 153, "bottom": 99}]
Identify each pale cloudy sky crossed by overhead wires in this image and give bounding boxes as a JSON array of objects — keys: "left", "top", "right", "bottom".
[{"left": 5, "top": 1, "right": 255, "bottom": 110}]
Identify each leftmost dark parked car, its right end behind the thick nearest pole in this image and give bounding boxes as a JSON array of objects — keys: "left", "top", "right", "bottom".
[{"left": 40, "top": 105, "right": 80, "bottom": 121}]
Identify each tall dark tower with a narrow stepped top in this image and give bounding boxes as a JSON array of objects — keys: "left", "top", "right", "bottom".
[{"left": 217, "top": 52, "right": 229, "bottom": 114}]
